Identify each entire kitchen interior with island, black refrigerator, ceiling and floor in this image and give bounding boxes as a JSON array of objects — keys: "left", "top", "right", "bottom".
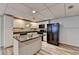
[{"left": 0, "top": 3, "right": 79, "bottom": 55}]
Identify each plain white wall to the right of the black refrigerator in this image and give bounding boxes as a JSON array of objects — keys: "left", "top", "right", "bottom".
[{"left": 50, "top": 16, "right": 79, "bottom": 47}]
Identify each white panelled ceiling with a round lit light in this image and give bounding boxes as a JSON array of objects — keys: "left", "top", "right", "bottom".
[{"left": 0, "top": 3, "right": 79, "bottom": 21}]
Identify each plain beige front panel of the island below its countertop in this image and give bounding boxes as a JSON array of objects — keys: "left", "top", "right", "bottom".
[{"left": 19, "top": 37, "right": 42, "bottom": 55}]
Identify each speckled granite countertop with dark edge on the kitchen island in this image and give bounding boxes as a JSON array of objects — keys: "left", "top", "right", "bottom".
[{"left": 13, "top": 31, "right": 44, "bottom": 42}]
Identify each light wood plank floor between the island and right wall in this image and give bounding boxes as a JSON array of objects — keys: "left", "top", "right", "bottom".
[{"left": 36, "top": 42, "right": 79, "bottom": 55}]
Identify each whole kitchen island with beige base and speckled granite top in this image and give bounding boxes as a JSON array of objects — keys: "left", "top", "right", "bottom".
[{"left": 14, "top": 31, "right": 42, "bottom": 55}]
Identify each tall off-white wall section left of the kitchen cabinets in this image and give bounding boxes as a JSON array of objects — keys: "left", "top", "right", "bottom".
[{"left": 2, "top": 16, "right": 13, "bottom": 47}]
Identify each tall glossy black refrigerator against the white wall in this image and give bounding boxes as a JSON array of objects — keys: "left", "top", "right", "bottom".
[{"left": 47, "top": 23, "right": 60, "bottom": 46}]
